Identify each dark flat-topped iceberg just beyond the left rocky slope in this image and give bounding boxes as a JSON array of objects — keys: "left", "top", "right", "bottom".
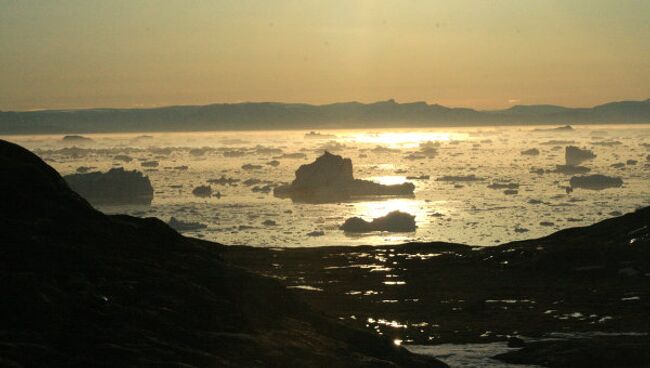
[{"left": 64, "top": 167, "right": 153, "bottom": 205}]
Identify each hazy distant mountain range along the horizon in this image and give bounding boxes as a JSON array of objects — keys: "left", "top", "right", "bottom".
[{"left": 0, "top": 99, "right": 650, "bottom": 134}]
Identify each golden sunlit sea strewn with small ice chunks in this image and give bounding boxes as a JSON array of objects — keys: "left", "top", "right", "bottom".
[{"left": 4, "top": 125, "right": 650, "bottom": 247}]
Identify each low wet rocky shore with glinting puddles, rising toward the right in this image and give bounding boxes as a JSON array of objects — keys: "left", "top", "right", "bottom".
[{"left": 222, "top": 207, "right": 650, "bottom": 368}]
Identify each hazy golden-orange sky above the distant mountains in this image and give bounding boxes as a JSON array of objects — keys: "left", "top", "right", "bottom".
[{"left": 0, "top": 0, "right": 650, "bottom": 110}]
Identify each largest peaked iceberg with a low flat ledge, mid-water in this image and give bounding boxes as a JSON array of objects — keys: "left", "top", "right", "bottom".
[{"left": 273, "top": 152, "right": 415, "bottom": 202}]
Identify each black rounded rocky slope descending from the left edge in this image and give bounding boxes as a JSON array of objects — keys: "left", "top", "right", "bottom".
[{"left": 0, "top": 141, "right": 445, "bottom": 367}]
